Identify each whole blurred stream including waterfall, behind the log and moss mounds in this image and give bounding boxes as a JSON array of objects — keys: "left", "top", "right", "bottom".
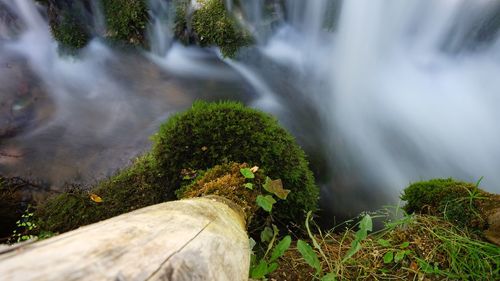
[{"left": 0, "top": 0, "right": 500, "bottom": 217}]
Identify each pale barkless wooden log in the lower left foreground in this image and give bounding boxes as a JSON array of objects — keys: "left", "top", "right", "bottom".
[{"left": 0, "top": 197, "right": 250, "bottom": 281}]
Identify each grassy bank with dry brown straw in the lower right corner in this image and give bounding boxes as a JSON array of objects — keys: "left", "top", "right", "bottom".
[{"left": 269, "top": 211, "right": 500, "bottom": 281}]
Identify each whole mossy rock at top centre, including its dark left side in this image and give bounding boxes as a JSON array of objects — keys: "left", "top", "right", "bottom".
[{"left": 174, "top": 0, "right": 252, "bottom": 57}]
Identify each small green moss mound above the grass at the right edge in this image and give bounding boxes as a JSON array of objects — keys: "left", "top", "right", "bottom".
[{"left": 401, "top": 178, "right": 488, "bottom": 229}]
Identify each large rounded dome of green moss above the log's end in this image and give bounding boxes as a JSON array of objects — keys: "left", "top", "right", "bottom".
[{"left": 152, "top": 102, "right": 319, "bottom": 224}]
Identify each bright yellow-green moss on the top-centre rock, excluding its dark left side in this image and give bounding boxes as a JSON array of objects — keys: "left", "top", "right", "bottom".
[{"left": 192, "top": 0, "right": 251, "bottom": 57}]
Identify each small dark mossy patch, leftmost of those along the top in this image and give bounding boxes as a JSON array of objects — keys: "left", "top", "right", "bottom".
[{"left": 51, "top": 12, "right": 90, "bottom": 51}]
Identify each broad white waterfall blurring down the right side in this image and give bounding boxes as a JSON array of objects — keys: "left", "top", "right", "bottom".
[{"left": 226, "top": 0, "right": 500, "bottom": 215}]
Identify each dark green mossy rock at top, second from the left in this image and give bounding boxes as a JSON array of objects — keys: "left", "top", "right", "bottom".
[{"left": 102, "top": 0, "right": 148, "bottom": 45}]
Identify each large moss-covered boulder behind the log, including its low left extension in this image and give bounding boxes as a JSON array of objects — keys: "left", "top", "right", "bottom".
[{"left": 35, "top": 102, "right": 319, "bottom": 232}]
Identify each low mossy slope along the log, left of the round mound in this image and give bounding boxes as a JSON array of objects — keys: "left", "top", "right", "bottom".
[{"left": 35, "top": 155, "right": 164, "bottom": 233}]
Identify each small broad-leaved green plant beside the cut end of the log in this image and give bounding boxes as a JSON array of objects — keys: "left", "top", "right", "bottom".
[{"left": 250, "top": 225, "right": 292, "bottom": 279}]
